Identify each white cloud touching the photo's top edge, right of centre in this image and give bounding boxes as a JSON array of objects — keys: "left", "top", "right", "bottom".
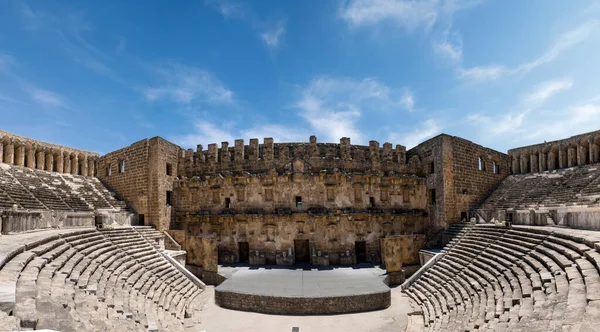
[{"left": 340, "top": 0, "right": 441, "bottom": 30}]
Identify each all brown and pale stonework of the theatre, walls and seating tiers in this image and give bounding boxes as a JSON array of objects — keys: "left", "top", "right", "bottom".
[{"left": 0, "top": 131, "right": 600, "bottom": 331}]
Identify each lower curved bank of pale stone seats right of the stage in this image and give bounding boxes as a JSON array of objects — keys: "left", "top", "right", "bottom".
[{"left": 405, "top": 225, "right": 600, "bottom": 331}]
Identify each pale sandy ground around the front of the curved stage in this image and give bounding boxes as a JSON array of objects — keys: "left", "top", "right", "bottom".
[{"left": 195, "top": 286, "right": 410, "bottom": 332}]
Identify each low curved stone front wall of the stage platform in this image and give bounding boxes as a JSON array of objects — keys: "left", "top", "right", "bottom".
[{"left": 215, "top": 290, "right": 391, "bottom": 315}]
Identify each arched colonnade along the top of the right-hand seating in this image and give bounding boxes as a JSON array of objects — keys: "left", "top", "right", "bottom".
[{"left": 511, "top": 135, "right": 600, "bottom": 174}]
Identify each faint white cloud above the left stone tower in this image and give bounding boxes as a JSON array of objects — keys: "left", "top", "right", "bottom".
[{"left": 141, "top": 63, "right": 234, "bottom": 104}]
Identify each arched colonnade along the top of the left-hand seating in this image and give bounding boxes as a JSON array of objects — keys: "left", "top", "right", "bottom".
[{"left": 0, "top": 136, "right": 98, "bottom": 176}]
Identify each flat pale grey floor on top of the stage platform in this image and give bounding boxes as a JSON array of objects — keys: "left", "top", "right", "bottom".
[{"left": 217, "top": 267, "right": 389, "bottom": 298}]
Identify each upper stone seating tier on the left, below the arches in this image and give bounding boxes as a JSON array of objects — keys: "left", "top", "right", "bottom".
[{"left": 0, "top": 164, "right": 126, "bottom": 212}]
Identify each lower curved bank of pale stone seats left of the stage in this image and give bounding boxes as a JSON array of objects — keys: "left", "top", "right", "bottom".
[{"left": 0, "top": 227, "right": 202, "bottom": 331}]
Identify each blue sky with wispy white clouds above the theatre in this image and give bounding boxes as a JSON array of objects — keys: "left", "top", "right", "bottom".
[{"left": 0, "top": 0, "right": 600, "bottom": 153}]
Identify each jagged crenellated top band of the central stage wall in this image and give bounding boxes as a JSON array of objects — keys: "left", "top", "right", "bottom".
[{"left": 180, "top": 136, "right": 406, "bottom": 176}]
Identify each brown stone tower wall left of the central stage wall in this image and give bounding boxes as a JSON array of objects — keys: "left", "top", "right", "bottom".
[{"left": 98, "top": 137, "right": 181, "bottom": 230}]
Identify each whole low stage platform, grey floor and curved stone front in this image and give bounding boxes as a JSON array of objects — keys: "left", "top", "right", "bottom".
[{"left": 215, "top": 266, "right": 391, "bottom": 315}]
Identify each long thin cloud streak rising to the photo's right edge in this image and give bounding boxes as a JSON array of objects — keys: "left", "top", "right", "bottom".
[{"left": 458, "top": 20, "right": 600, "bottom": 83}]
